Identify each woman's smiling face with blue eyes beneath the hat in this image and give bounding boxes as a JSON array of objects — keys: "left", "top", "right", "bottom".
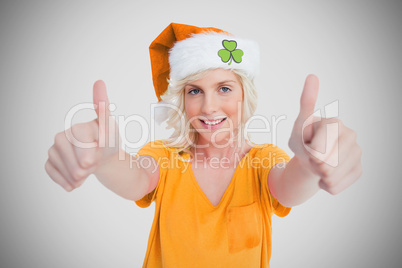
[{"left": 184, "top": 69, "right": 243, "bottom": 145}]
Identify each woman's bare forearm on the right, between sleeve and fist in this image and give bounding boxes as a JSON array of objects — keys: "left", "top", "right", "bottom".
[{"left": 272, "top": 157, "right": 320, "bottom": 207}]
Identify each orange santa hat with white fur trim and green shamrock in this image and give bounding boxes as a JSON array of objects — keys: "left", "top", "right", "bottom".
[{"left": 149, "top": 23, "right": 259, "bottom": 101}]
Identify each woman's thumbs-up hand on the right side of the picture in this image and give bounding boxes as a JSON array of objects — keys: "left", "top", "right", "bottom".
[{"left": 289, "top": 75, "right": 362, "bottom": 194}]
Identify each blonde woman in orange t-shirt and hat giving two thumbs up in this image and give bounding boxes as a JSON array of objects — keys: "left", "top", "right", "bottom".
[{"left": 45, "top": 23, "right": 361, "bottom": 267}]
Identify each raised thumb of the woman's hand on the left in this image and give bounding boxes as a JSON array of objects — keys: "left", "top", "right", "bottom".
[{"left": 93, "top": 80, "right": 110, "bottom": 147}]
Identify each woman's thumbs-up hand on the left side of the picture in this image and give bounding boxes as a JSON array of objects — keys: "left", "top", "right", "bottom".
[{"left": 45, "top": 80, "right": 120, "bottom": 191}]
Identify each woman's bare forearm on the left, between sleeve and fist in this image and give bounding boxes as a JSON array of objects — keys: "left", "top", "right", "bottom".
[{"left": 94, "top": 150, "right": 153, "bottom": 201}]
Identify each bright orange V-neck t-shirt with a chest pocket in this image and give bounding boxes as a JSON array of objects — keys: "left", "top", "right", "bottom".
[{"left": 136, "top": 141, "right": 290, "bottom": 268}]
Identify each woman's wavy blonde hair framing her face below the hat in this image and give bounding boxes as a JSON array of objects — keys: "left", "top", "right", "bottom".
[{"left": 161, "top": 69, "right": 257, "bottom": 152}]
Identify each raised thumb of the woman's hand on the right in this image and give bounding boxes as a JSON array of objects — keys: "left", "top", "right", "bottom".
[{"left": 299, "top": 74, "right": 319, "bottom": 119}]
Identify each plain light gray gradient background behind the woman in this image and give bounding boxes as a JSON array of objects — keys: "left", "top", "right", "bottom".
[{"left": 0, "top": 0, "right": 402, "bottom": 268}]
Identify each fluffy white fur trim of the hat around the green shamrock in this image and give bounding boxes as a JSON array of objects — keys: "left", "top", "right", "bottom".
[{"left": 169, "top": 32, "right": 260, "bottom": 81}]
